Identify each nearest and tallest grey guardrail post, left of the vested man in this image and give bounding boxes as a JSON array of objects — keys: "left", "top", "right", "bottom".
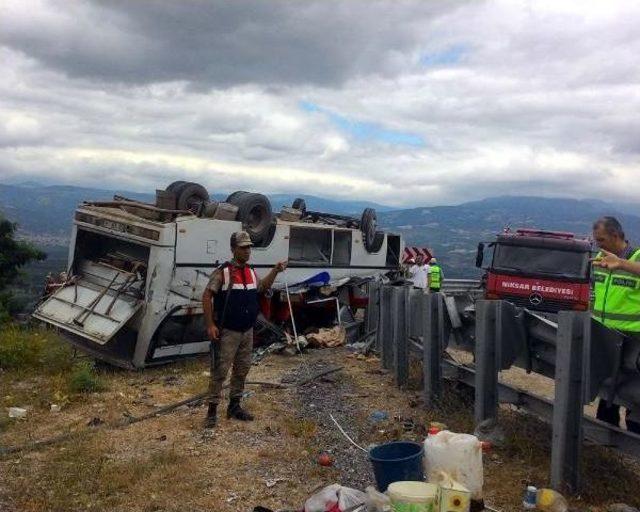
[{"left": 551, "top": 311, "right": 591, "bottom": 493}]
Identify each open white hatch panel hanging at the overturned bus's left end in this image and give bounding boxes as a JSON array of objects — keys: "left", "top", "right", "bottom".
[{"left": 33, "top": 273, "right": 143, "bottom": 345}]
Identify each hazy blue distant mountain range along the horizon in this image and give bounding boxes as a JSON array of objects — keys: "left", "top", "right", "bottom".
[{"left": 0, "top": 183, "right": 640, "bottom": 277}]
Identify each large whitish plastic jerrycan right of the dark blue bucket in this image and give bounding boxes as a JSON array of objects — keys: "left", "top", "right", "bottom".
[{"left": 424, "top": 430, "right": 484, "bottom": 500}]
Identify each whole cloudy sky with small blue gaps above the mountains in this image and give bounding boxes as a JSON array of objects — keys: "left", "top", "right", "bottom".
[{"left": 0, "top": 0, "right": 640, "bottom": 206}]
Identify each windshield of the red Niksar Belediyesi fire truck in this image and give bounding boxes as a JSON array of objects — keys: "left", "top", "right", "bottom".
[{"left": 492, "top": 244, "right": 589, "bottom": 279}]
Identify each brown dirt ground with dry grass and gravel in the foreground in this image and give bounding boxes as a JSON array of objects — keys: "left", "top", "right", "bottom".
[{"left": 0, "top": 348, "right": 640, "bottom": 512}]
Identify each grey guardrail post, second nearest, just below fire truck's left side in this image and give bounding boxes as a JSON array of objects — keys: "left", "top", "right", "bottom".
[{"left": 475, "top": 300, "right": 499, "bottom": 424}]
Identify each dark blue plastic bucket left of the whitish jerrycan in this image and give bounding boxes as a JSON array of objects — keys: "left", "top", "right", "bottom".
[{"left": 369, "top": 441, "right": 424, "bottom": 492}]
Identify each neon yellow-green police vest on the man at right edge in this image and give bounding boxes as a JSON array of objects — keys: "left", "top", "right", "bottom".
[{"left": 592, "top": 249, "right": 640, "bottom": 332}]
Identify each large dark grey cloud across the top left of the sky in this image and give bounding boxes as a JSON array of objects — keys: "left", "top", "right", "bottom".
[{"left": 0, "top": 0, "right": 460, "bottom": 87}]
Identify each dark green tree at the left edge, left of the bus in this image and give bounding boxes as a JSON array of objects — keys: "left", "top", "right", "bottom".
[{"left": 0, "top": 216, "right": 47, "bottom": 323}]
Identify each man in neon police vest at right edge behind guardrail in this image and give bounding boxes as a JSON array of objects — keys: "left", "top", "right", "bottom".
[{"left": 591, "top": 217, "right": 640, "bottom": 433}]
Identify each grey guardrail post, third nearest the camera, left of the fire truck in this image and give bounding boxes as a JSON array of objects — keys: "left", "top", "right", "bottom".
[{"left": 422, "top": 293, "right": 444, "bottom": 407}]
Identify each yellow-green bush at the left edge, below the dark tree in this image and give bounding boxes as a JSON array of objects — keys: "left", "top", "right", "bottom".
[{"left": 0, "top": 324, "right": 74, "bottom": 374}]
